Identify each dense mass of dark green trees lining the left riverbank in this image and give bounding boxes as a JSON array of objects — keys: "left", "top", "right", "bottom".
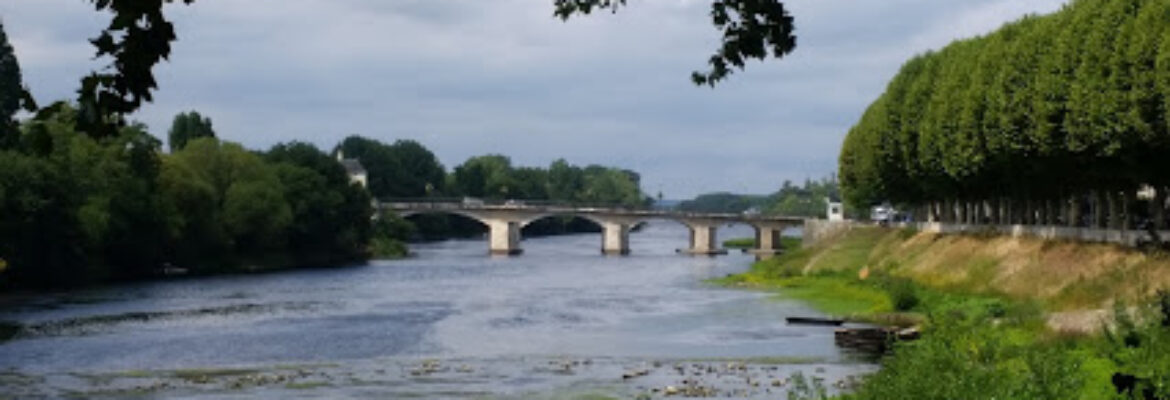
[{"left": 0, "top": 103, "right": 373, "bottom": 288}]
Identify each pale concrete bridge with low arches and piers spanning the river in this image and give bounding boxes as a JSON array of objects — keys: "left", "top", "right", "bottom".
[{"left": 378, "top": 200, "right": 804, "bottom": 255}]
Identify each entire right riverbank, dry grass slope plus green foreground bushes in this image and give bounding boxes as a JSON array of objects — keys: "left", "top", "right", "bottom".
[{"left": 718, "top": 228, "right": 1170, "bottom": 399}]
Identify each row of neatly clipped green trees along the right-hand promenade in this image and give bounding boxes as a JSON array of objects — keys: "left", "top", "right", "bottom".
[{"left": 840, "top": 0, "right": 1170, "bottom": 228}]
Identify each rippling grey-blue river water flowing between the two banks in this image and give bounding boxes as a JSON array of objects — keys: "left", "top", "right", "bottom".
[{"left": 0, "top": 222, "right": 875, "bottom": 399}]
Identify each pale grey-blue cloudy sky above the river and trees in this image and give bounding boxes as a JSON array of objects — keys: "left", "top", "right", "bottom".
[{"left": 0, "top": 0, "right": 1064, "bottom": 199}]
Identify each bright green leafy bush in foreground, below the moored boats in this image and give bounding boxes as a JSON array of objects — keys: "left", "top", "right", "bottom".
[{"left": 849, "top": 313, "right": 1107, "bottom": 400}]
